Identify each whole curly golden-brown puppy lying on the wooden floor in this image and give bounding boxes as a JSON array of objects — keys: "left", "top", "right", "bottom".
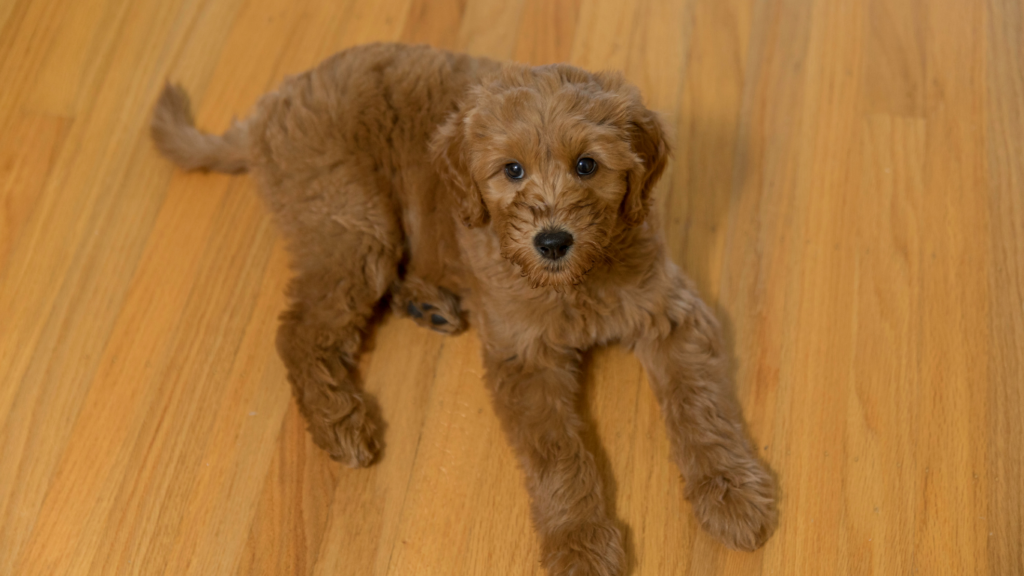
[{"left": 153, "top": 44, "right": 776, "bottom": 575}]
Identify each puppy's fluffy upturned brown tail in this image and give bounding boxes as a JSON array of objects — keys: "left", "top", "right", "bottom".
[{"left": 150, "top": 84, "right": 249, "bottom": 172}]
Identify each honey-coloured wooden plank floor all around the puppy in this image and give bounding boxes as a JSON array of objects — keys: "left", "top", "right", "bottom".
[{"left": 0, "top": 0, "right": 1024, "bottom": 576}]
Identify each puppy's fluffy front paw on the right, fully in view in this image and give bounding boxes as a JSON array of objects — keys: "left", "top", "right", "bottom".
[{"left": 686, "top": 463, "right": 778, "bottom": 551}]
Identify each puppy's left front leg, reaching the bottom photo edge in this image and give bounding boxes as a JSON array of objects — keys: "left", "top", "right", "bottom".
[{"left": 484, "top": 344, "right": 624, "bottom": 576}]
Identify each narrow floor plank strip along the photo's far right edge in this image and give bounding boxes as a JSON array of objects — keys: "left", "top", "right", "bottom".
[{"left": 972, "top": 1, "right": 1024, "bottom": 574}]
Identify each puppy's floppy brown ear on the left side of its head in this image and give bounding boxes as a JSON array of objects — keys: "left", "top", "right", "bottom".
[{"left": 430, "top": 111, "right": 489, "bottom": 228}]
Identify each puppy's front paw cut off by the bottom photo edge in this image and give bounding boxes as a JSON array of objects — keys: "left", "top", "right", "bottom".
[{"left": 544, "top": 521, "right": 626, "bottom": 576}]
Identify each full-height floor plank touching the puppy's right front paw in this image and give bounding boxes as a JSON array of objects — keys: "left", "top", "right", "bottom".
[{"left": 712, "top": 1, "right": 815, "bottom": 574}]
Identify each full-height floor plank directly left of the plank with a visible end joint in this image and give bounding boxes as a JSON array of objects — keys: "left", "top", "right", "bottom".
[{"left": 779, "top": 3, "right": 872, "bottom": 573}]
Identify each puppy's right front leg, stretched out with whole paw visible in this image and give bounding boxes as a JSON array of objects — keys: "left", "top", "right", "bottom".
[{"left": 635, "top": 277, "right": 777, "bottom": 550}]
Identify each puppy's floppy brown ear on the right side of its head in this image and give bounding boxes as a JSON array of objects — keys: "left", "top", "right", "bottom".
[{"left": 622, "top": 109, "right": 669, "bottom": 225}]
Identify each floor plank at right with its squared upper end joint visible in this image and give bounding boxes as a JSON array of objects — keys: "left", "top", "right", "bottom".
[{"left": 844, "top": 116, "right": 927, "bottom": 574}]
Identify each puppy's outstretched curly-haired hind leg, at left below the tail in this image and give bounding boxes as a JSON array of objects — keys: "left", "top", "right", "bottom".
[{"left": 271, "top": 174, "right": 401, "bottom": 461}]
